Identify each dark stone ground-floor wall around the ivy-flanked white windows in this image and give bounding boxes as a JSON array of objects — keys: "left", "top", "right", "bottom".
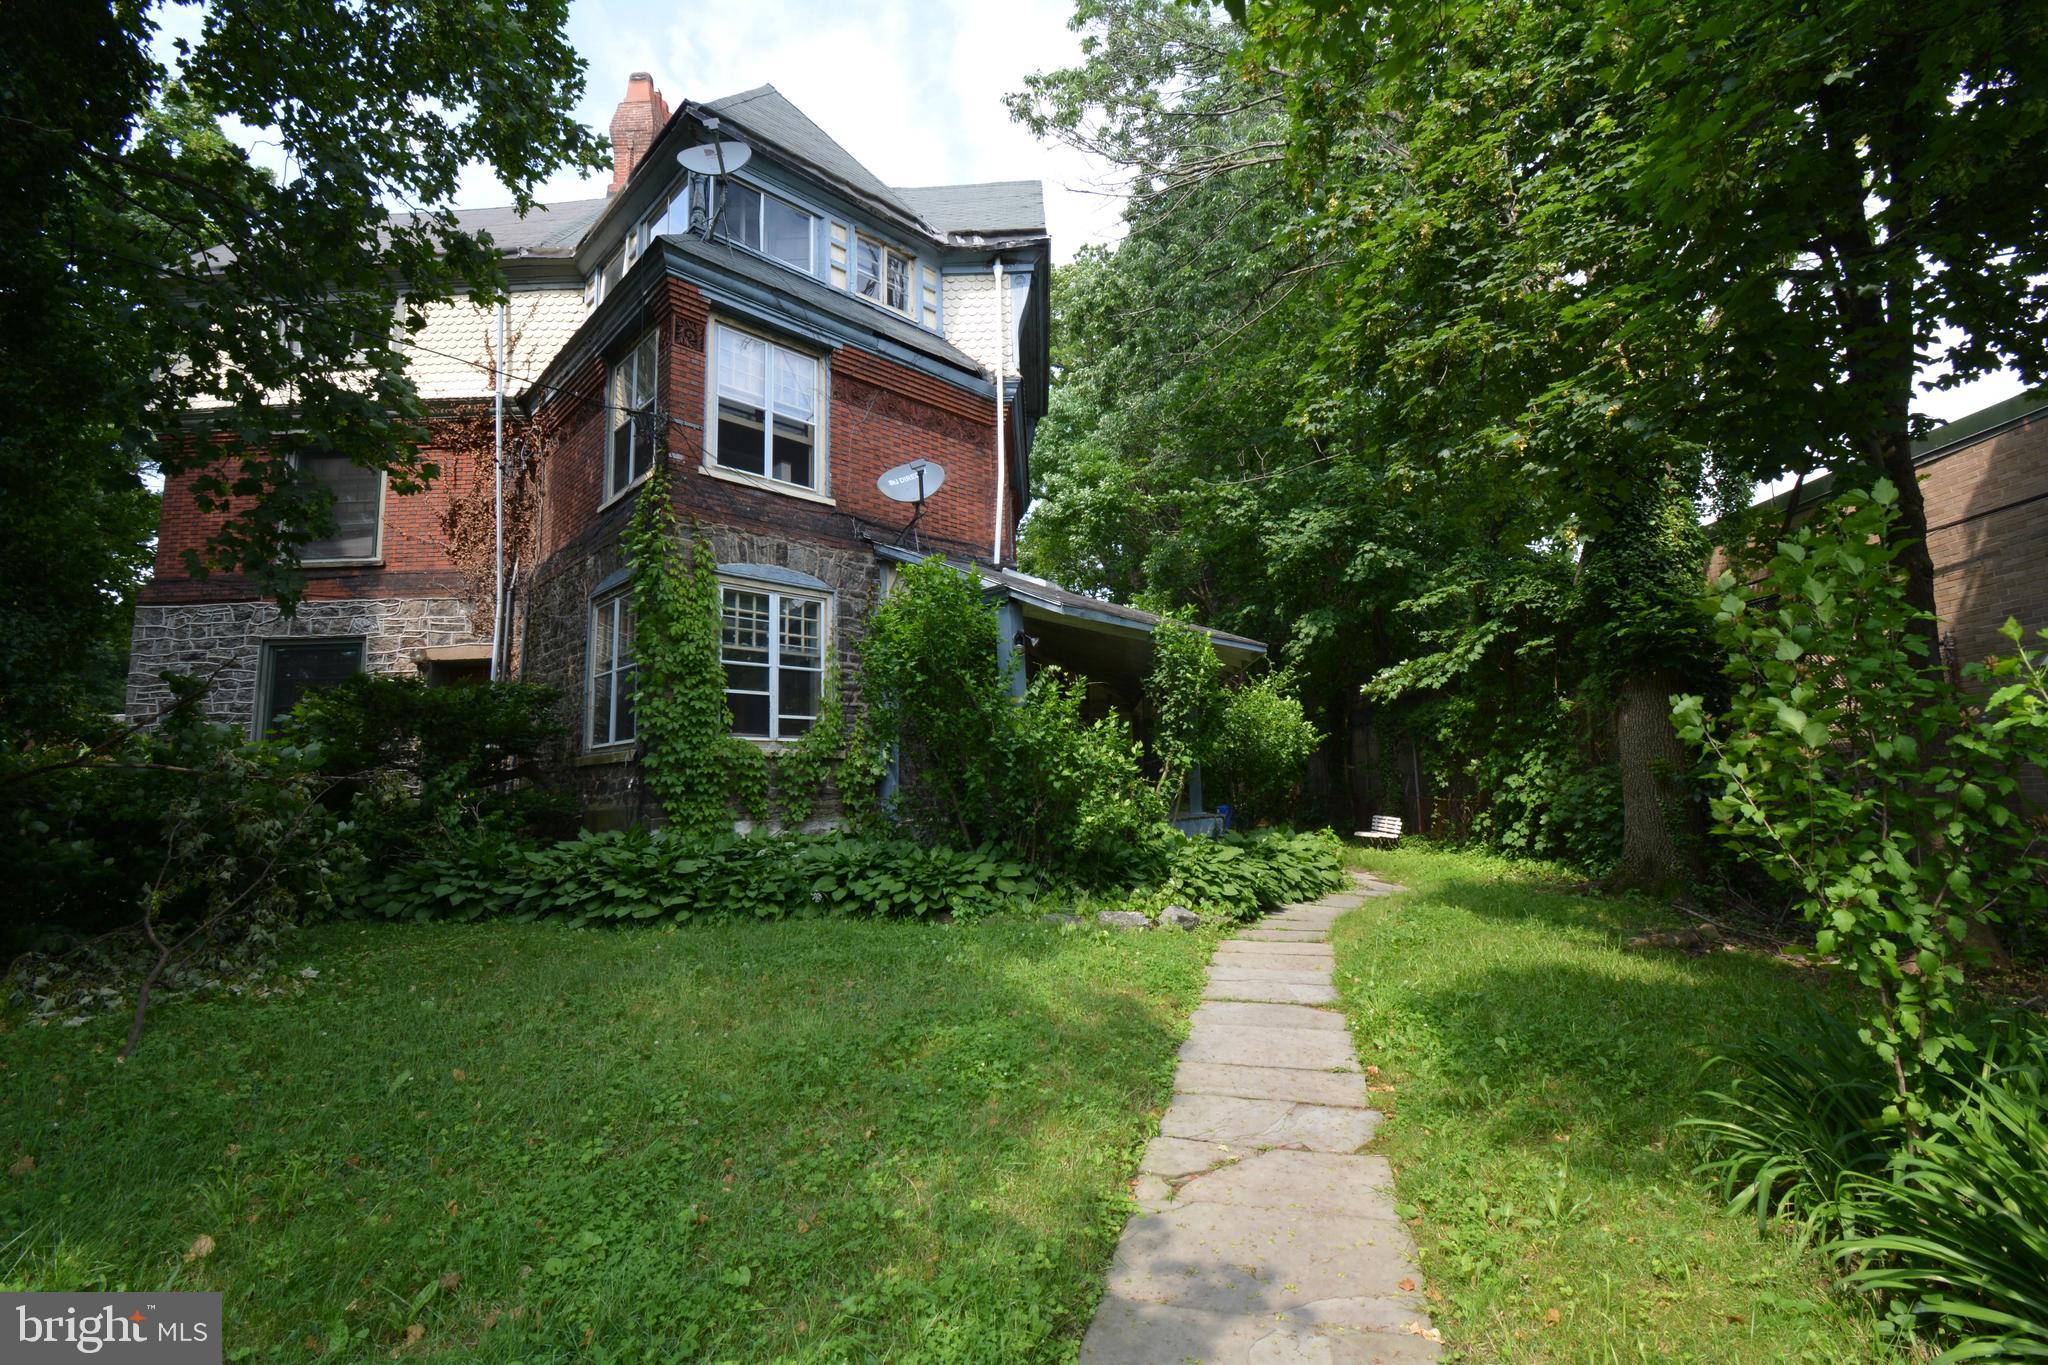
[{"left": 514, "top": 518, "right": 881, "bottom": 829}]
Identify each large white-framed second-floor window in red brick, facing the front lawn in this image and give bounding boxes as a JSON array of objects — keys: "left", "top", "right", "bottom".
[{"left": 709, "top": 323, "right": 825, "bottom": 491}]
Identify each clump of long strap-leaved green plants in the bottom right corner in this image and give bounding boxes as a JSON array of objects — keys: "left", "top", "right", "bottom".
[{"left": 1686, "top": 1011, "right": 2048, "bottom": 1361}]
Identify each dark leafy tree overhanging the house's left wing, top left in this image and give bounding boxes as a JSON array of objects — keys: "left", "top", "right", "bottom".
[{"left": 0, "top": 0, "right": 602, "bottom": 733}]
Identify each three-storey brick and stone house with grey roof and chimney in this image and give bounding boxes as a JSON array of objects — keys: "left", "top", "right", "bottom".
[{"left": 129, "top": 74, "right": 1264, "bottom": 825}]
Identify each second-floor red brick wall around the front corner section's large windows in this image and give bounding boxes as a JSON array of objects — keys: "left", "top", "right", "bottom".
[{"left": 541, "top": 280, "right": 1018, "bottom": 561}]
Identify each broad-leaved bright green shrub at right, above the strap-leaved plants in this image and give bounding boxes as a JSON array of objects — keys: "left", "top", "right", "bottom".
[{"left": 1675, "top": 479, "right": 2048, "bottom": 1126}]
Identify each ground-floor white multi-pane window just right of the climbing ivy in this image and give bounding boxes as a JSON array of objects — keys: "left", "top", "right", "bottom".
[{"left": 719, "top": 583, "right": 831, "bottom": 739}]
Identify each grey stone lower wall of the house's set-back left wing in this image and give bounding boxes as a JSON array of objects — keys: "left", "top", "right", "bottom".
[{"left": 127, "top": 598, "right": 487, "bottom": 724}]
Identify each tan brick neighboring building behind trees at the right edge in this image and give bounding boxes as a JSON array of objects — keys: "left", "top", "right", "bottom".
[{"left": 1763, "top": 389, "right": 2048, "bottom": 677}]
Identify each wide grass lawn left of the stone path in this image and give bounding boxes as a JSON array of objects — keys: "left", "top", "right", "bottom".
[{"left": 0, "top": 921, "right": 1210, "bottom": 1363}]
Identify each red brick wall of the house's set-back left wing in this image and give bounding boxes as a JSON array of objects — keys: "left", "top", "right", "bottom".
[{"left": 141, "top": 431, "right": 489, "bottom": 604}]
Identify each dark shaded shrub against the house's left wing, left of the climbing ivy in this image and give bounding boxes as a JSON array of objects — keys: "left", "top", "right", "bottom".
[{"left": 279, "top": 673, "right": 575, "bottom": 860}]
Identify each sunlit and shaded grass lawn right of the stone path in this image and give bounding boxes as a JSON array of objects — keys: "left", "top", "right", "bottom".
[{"left": 1333, "top": 849, "right": 1894, "bottom": 1363}]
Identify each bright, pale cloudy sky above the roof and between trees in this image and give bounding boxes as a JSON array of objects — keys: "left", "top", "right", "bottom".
[{"left": 160, "top": 0, "right": 2021, "bottom": 422}]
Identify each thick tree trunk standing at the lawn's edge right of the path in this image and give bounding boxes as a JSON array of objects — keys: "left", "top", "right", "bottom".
[{"left": 1610, "top": 669, "right": 1696, "bottom": 894}]
